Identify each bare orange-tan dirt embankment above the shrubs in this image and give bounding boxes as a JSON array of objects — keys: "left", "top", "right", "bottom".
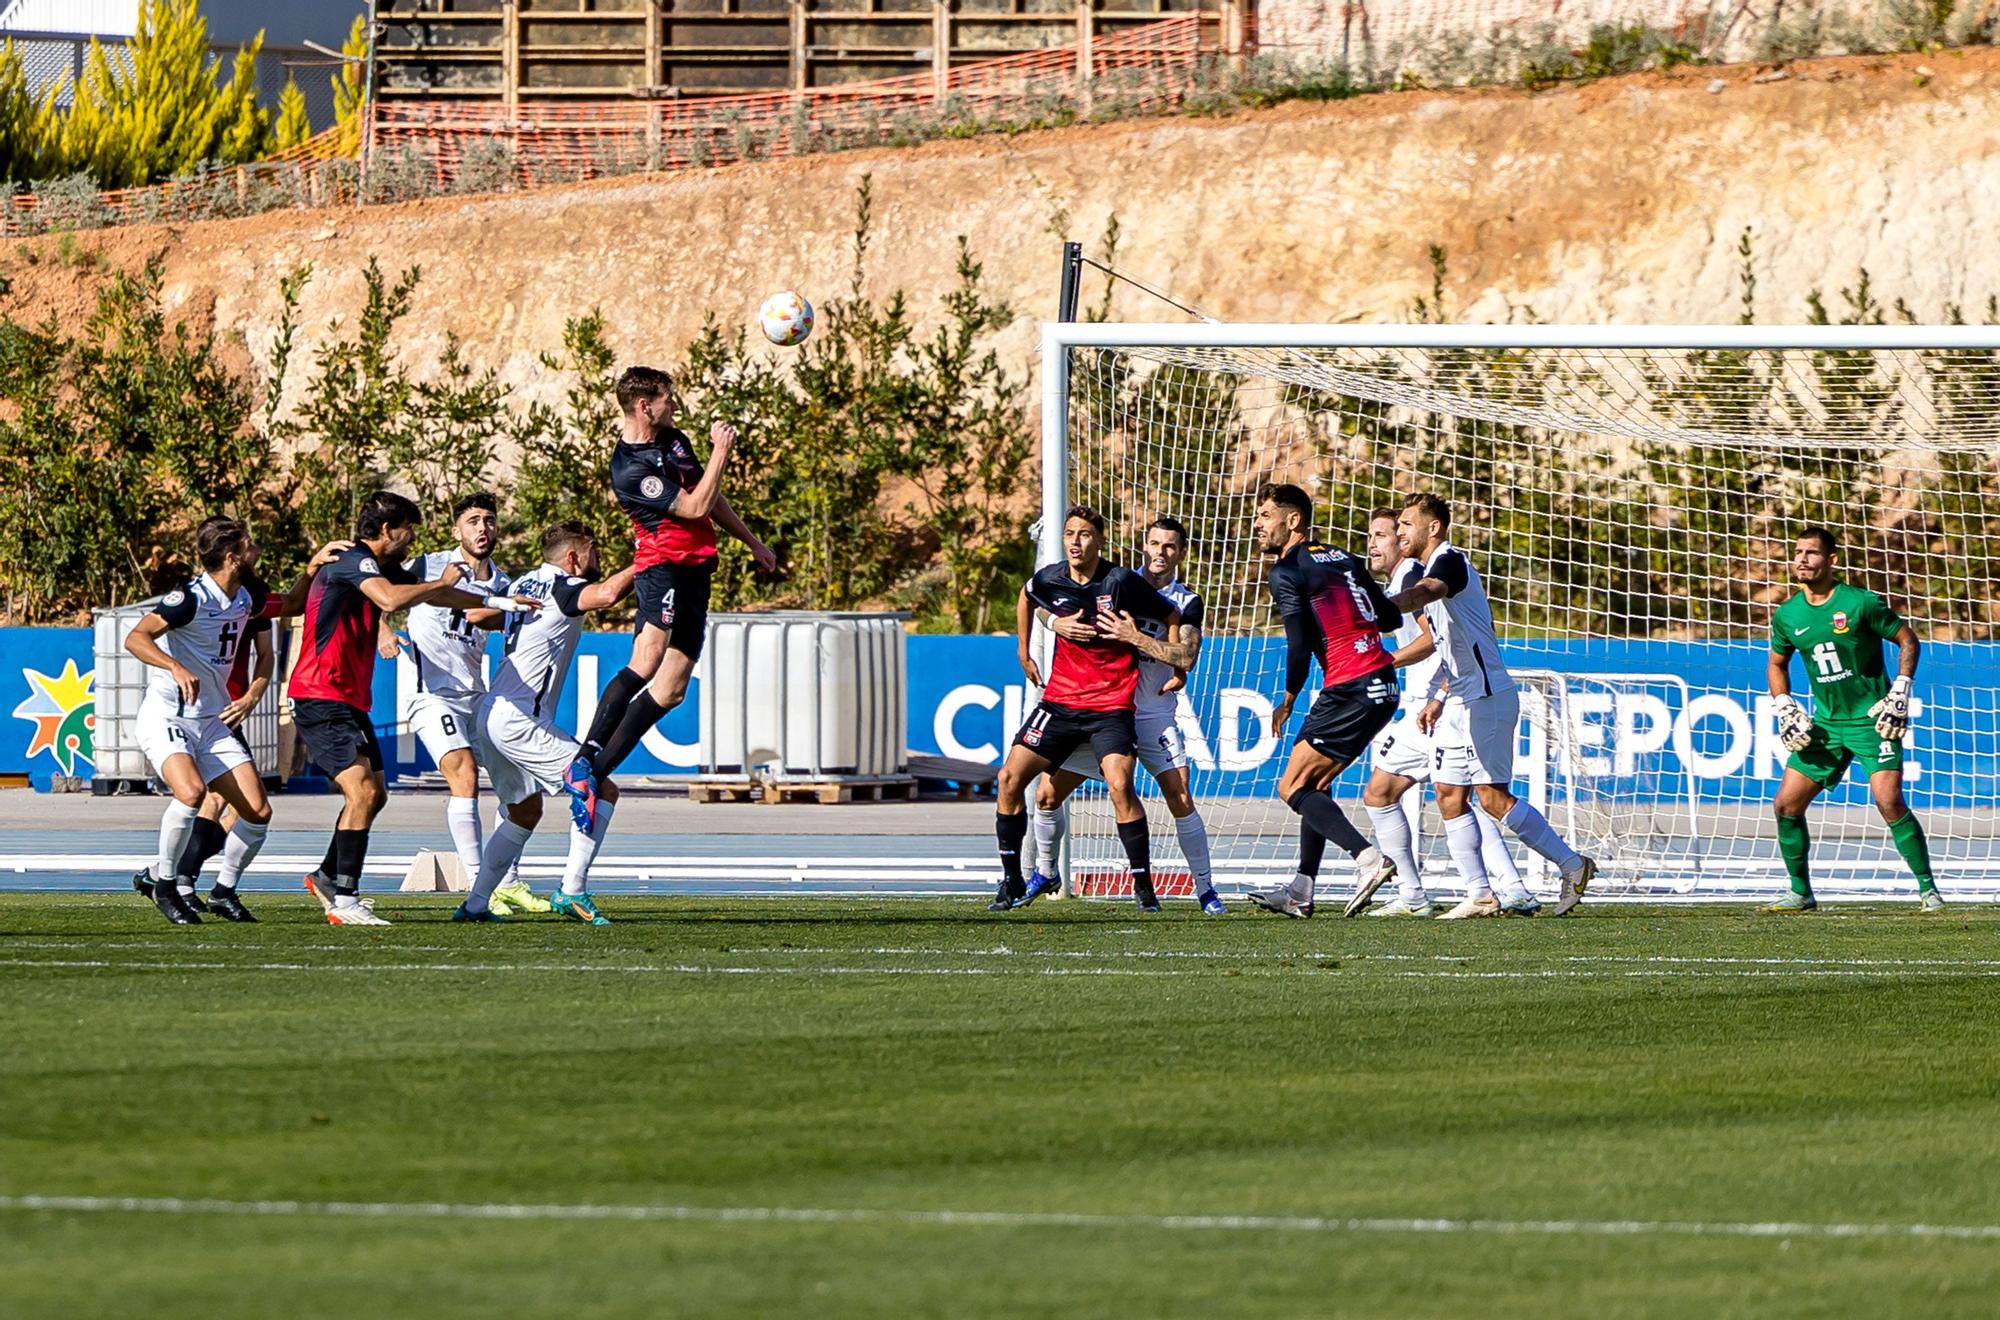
[{"left": 0, "top": 50, "right": 2000, "bottom": 410}]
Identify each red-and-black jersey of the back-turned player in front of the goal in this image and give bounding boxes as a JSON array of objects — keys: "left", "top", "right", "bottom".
[{"left": 1270, "top": 540, "right": 1402, "bottom": 692}]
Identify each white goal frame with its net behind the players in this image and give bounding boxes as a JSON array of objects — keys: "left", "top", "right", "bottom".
[{"left": 1042, "top": 324, "right": 2000, "bottom": 900}]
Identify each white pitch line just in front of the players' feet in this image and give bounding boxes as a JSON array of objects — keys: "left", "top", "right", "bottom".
[{"left": 0, "top": 960, "right": 2000, "bottom": 980}]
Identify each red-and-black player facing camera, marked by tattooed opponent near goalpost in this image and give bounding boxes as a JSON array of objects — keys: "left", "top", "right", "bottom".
[{"left": 990, "top": 504, "right": 1180, "bottom": 912}]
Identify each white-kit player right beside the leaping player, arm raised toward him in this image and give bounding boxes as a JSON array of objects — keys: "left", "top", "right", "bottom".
[{"left": 452, "top": 522, "right": 636, "bottom": 926}]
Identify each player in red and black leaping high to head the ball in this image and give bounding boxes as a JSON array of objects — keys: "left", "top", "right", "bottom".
[{"left": 564, "top": 366, "right": 778, "bottom": 812}]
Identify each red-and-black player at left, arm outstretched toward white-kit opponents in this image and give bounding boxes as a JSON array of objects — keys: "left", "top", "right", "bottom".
[{"left": 290, "top": 490, "right": 542, "bottom": 926}]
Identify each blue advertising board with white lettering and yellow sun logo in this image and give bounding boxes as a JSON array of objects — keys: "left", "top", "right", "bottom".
[{"left": 0, "top": 628, "right": 2000, "bottom": 806}]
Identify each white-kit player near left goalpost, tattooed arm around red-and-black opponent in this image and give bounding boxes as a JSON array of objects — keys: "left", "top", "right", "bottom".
[{"left": 1018, "top": 518, "right": 1228, "bottom": 916}]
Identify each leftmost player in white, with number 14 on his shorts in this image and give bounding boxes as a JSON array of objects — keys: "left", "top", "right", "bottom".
[{"left": 124, "top": 518, "right": 346, "bottom": 926}]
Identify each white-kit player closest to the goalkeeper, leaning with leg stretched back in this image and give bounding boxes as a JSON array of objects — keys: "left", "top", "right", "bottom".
[{"left": 1394, "top": 494, "right": 1598, "bottom": 920}]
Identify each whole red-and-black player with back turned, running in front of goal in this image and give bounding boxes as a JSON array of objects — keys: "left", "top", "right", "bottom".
[{"left": 1250, "top": 484, "right": 1402, "bottom": 916}]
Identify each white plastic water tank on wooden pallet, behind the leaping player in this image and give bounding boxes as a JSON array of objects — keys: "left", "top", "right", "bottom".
[{"left": 694, "top": 610, "right": 910, "bottom": 780}]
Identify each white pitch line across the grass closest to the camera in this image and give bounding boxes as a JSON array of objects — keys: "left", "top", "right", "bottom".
[{"left": 0, "top": 1196, "right": 2000, "bottom": 1242}]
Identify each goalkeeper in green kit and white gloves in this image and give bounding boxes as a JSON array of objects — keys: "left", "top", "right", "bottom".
[{"left": 1764, "top": 528, "right": 1944, "bottom": 912}]
